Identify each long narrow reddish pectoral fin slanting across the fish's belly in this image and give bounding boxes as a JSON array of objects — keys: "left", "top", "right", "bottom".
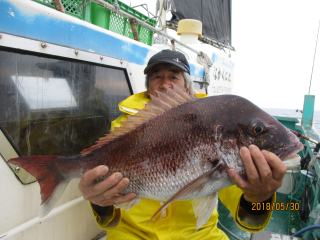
[{"left": 148, "top": 166, "right": 219, "bottom": 223}]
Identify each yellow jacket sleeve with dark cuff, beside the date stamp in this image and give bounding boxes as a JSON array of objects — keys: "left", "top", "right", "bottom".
[{"left": 219, "top": 185, "right": 276, "bottom": 232}]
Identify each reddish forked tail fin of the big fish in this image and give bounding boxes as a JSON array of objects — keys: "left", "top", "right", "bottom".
[{"left": 9, "top": 156, "right": 70, "bottom": 217}]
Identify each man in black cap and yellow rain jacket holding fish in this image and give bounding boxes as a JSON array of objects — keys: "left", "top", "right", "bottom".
[{"left": 79, "top": 50, "right": 286, "bottom": 239}]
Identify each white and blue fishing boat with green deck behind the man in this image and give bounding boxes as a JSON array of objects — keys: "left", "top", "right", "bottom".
[{"left": 0, "top": 0, "right": 320, "bottom": 240}]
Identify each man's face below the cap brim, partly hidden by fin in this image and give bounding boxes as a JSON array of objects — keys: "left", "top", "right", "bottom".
[{"left": 148, "top": 64, "right": 189, "bottom": 96}]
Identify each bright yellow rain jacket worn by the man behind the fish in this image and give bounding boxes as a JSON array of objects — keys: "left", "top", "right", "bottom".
[{"left": 90, "top": 92, "right": 275, "bottom": 240}]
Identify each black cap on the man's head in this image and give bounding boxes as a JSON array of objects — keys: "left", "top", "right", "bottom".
[{"left": 144, "top": 50, "right": 190, "bottom": 75}]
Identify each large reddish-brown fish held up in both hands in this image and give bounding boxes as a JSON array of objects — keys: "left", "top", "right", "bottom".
[{"left": 9, "top": 86, "right": 303, "bottom": 229}]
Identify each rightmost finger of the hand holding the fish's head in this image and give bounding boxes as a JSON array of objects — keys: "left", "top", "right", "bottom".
[{"left": 262, "top": 151, "right": 287, "bottom": 181}]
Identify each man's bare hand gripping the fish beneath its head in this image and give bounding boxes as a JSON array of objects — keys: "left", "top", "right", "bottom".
[{"left": 229, "top": 145, "right": 287, "bottom": 202}]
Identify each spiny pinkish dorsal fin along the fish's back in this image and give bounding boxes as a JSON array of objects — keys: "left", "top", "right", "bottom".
[{"left": 81, "top": 84, "right": 194, "bottom": 155}]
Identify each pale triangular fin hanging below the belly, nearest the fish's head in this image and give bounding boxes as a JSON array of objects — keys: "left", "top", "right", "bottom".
[{"left": 192, "top": 192, "right": 219, "bottom": 231}]
